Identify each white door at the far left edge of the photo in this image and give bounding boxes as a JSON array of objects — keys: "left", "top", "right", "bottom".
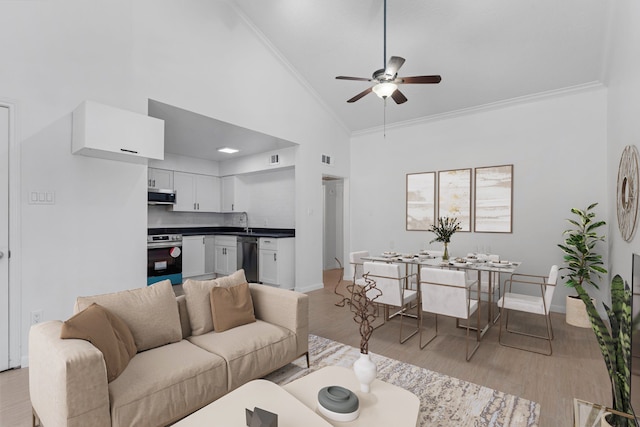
[{"left": 0, "top": 107, "right": 9, "bottom": 371}]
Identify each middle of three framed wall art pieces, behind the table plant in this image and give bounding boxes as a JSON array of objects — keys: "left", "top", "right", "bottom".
[{"left": 438, "top": 169, "right": 471, "bottom": 231}]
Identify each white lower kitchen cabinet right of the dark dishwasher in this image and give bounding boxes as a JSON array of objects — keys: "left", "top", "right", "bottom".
[{"left": 258, "top": 237, "right": 295, "bottom": 289}]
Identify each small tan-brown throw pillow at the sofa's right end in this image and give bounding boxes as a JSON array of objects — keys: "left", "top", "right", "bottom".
[{"left": 211, "top": 282, "right": 256, "bottom": 332}]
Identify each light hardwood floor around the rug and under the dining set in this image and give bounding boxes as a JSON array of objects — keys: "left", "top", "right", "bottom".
[{"left": 0, "top": 270, "right": 611, "bottom": 427}]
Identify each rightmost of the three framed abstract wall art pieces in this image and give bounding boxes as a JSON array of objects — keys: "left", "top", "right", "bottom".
[{"left": 474, "top": 165, "right": 513, "bottom": 233}]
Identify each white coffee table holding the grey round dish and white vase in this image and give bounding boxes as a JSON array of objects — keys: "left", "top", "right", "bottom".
[{"left": 283, "top": 366, "right": 420, "bottom": 427}]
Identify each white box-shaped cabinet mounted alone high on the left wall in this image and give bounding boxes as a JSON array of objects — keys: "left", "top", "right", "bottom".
[{"left": 71, "top": 101, "right": 164, "bottom": 164}]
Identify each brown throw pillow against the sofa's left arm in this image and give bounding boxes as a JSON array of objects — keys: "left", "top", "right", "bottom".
[{"left": 60, "top": 303, "right": 136, "bottom": 382}]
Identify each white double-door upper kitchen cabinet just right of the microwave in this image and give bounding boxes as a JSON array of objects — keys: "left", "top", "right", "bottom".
[{"left": 172, "top": 171, "right": 220, "bottom": 212}]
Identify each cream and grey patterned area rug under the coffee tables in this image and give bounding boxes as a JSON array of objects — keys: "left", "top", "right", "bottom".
[{"left": 266, "top": 335, "right": 540, "bottom": 427}]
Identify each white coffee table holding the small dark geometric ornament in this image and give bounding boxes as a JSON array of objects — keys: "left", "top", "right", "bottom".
[{"left": 174, "top": 380, "right": 331, "bottom": 427}]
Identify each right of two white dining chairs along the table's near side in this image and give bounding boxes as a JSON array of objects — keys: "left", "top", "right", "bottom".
[{"left": 420, "top": 267, "right": 488, "bottom": 362}]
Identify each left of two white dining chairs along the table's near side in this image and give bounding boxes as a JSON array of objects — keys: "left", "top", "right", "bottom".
[{"left": 363, "top": 262, "right": 420, "bottom": 344}]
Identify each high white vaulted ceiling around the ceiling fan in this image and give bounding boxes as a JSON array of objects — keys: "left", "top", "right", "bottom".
[{"left": 230, "top": 0, "right": 611, "bottom": 132}]
